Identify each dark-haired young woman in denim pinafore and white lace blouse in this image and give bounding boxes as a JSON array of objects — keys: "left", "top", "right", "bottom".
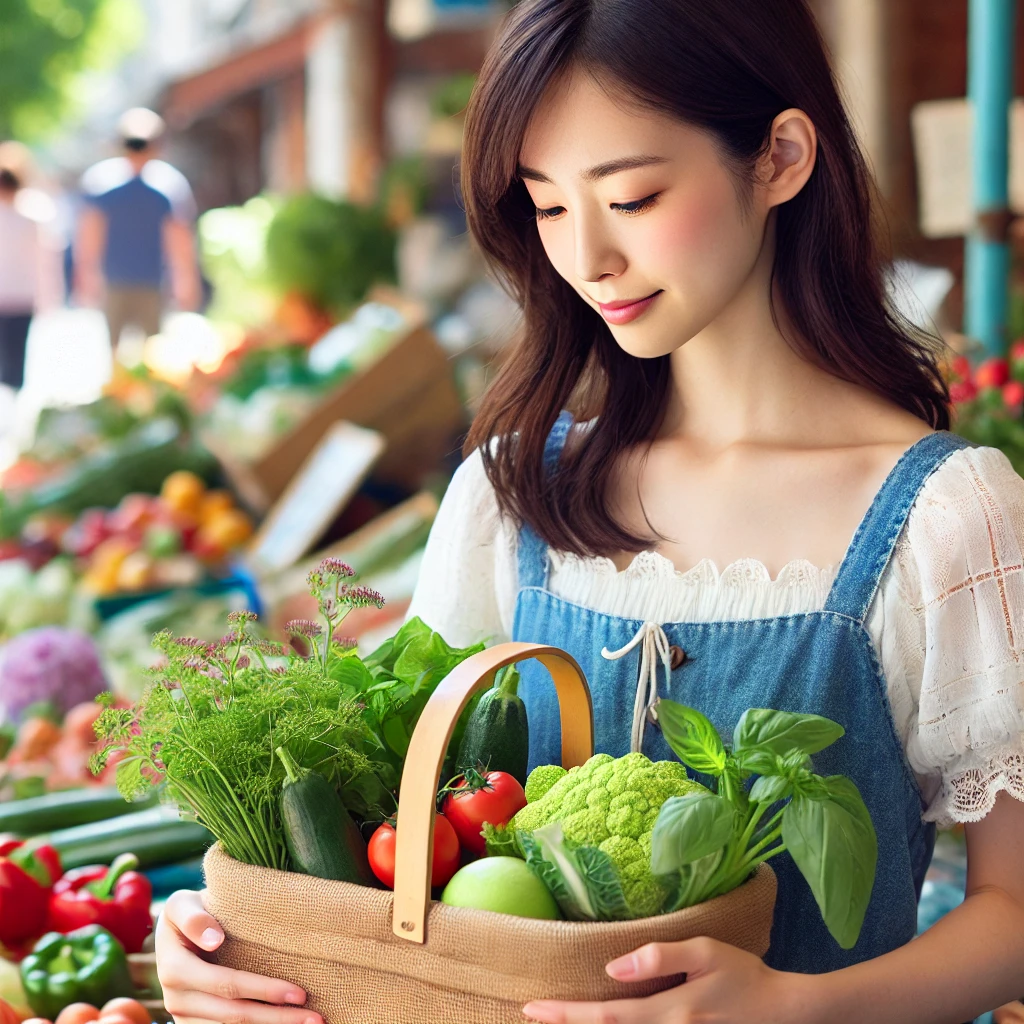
[{"left": 158, "top": 0, "right": 1024, "bottom": 1024}]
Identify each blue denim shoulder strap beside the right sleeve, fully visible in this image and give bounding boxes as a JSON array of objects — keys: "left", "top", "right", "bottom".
[{"left": 825, "top": 430, "right": 971, "bottom": 622}]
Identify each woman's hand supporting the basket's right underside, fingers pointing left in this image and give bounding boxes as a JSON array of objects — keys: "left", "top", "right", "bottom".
[{"left": 522, "top": 939, "right": 810, "bottom": 1024}]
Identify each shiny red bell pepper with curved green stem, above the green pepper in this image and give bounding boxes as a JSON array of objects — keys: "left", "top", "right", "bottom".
[{"left": 50, "top": 853, "right": 153, "bottom": 953}]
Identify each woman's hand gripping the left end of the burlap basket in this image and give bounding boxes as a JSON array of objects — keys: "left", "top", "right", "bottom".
[{"left": 157, "top": 891, "right": 324, "bottom": 1024}]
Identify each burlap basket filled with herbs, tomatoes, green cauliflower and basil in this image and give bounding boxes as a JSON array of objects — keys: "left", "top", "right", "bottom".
[{"left": 96, "top": 560, "right": 877, "bottom": 1024}]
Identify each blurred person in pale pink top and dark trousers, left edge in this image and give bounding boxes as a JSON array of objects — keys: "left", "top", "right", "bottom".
[{"left": 0, "top": 142, "right": 58, "bottom": 391}]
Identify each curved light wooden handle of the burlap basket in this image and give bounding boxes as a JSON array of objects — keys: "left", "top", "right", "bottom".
[{"left": 391, "top": 642, "right": 594, "bottom": 943}]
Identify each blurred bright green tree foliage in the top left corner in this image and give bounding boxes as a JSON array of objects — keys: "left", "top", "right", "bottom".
[{"left": 0, "top": 0, "right": 143, "bottom": 140}]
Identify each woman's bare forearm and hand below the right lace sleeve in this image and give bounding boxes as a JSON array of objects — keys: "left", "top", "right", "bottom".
[{"left": 523, "top": 794, "right": 1024, "bottom": 1024}]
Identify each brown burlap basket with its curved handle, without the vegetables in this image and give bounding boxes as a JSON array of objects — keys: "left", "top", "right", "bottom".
[{"left": 205, "top": 643, "right": 775, "bottom": 1024}]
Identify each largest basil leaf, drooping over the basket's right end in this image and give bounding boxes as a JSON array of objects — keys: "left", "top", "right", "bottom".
[{"left": 782, "top": 775, "right": 879, "bottom": 949}]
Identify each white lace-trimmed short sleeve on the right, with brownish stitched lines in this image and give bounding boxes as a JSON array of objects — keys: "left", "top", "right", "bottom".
[{"left": 907, "top": 449, "right": 1024, "bottom": 824}]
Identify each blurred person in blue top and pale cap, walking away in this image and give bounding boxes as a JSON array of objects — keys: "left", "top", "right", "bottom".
[{"left": 75, "top": 108, "right": 201, "bottom": 352}]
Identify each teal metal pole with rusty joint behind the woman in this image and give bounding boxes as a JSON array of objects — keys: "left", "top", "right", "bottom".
[{"left": 965, "top": 0, "right": 1016, "bottom": 355}]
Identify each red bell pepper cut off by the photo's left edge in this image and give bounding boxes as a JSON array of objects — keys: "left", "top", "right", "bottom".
[{"left": 0, "top": 840, "right": 60, "bottom": 946}]
